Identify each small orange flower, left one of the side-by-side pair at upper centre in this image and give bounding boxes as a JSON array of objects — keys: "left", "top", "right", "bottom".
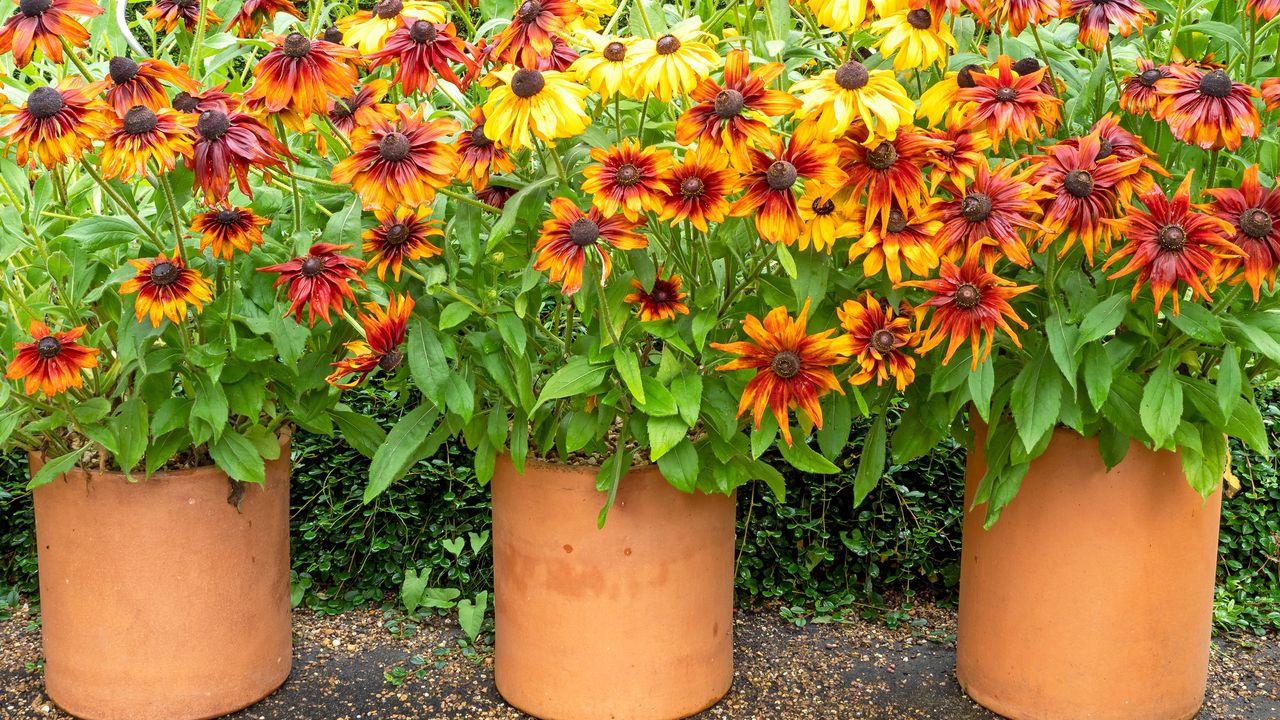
[{"left": 582, "top": 140, "right": 671, "bottom": 223}]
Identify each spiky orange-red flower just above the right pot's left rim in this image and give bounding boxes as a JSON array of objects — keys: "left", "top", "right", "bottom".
[{"left": 899, "top": 245, "right": 1036, "bottom": 369}]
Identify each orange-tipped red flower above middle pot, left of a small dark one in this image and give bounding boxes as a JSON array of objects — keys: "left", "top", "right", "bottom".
[{"left": 534, "top": 197, "right": 649, "bottom": 295}]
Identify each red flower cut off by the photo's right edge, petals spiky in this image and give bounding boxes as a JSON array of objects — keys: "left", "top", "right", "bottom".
[{"left": 1204, "top": 165, "right": 1280, "bottom": 302}]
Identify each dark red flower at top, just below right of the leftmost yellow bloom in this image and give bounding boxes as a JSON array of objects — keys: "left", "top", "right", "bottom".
[{"left": 369, "top": 20, "right": 471, "bottom": 94}]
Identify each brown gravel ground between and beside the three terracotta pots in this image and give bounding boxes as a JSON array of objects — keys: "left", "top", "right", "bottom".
[{"left": 0, "top": 606, "right": 1280, "bottom": 720}]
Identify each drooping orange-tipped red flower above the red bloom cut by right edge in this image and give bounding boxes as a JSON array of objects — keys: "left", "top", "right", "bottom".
[{"left": 1156, "top": 63, "right": 1262, "bottom": 150}]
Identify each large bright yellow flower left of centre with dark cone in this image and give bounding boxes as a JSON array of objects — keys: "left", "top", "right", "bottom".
[{"left": 484, "top": 67, "right": 591, "bottom": 152}]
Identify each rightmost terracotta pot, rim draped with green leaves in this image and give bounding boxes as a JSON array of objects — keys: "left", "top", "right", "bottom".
[{"left": 956, "top": 430, "right": 1222, "bottom": 720}]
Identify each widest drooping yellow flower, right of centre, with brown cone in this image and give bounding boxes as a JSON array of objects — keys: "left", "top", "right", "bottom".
[{"left": 791, "top": 60, "right": 915, "bottom": 145}]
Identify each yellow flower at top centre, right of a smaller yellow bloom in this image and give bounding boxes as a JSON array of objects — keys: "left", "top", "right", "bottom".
[{"left": 635, "top": 18, "right": 721, "bottom": 102}]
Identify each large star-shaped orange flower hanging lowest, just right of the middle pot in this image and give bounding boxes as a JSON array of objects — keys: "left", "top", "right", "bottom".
[{"left": 712, "top": 300, "right": 852, "bottom": 445}]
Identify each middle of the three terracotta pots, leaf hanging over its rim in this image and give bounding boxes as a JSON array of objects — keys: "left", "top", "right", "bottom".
[{"left": 493, "top": 457, "right": 736, "bottom": 720}]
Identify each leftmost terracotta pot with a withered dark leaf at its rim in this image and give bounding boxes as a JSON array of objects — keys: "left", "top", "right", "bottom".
[{"left": 31, "top": 439, "right": 292, "bottom": 720}]
